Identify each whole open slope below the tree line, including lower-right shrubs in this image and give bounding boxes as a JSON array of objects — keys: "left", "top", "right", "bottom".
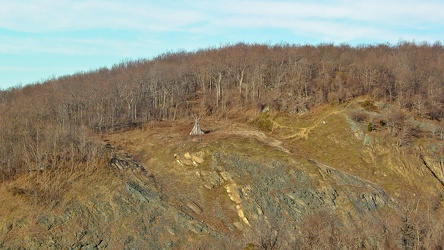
[{"left": 0, "top": 98, "right": 444, "bottom": 249}]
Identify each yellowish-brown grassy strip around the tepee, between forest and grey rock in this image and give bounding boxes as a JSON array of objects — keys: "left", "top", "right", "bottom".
[{"left": 103, "top": 100, "right": 442, "bottom": 208}]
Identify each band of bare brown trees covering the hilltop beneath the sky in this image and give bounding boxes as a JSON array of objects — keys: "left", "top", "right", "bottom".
[{"left": 0, "top": 42, "right": 444, "bottom": 180}]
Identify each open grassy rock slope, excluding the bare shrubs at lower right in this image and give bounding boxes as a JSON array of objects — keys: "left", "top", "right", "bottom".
[{"left": 0, "top": 109, "right": 444, "bottom": 249}]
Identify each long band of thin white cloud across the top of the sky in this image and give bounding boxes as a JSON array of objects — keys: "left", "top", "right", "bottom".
[{"left": 0, "top": 0, "right": 444, "bottom": 46}]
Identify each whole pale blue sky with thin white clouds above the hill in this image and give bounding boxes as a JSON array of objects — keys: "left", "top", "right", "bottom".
[{"left": 0, "top": 0, "right": 444, "bottom": 89}]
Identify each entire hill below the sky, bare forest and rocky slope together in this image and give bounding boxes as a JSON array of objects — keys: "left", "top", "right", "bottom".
[{"left": 0, "top": 43, "right": 444, "bottom": 249}]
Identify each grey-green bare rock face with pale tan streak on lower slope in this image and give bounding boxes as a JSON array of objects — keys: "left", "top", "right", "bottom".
[{"left": 1, "top": 147, "right": 389, "bottom": 249}]
